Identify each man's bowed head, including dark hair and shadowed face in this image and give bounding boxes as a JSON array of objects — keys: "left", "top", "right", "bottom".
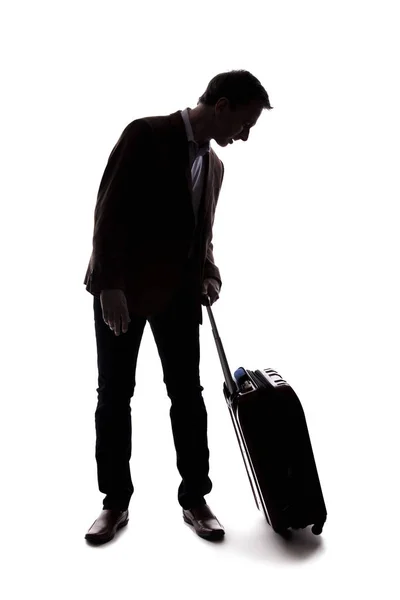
[{"left": 189, "top": 70, "right": 272, "bottom": 146}]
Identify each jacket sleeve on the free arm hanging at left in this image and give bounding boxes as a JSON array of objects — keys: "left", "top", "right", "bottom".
[{"left": 90, "top": 120, "right": 152, "bottom": 293}]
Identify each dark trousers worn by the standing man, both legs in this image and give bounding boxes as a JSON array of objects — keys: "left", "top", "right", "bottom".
[{"left": 94, "top": 272, "right": 212, "bottom": 510}]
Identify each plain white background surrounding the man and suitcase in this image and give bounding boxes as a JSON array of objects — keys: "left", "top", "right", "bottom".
[{"left": 0, "top": 0, "right": 400, "bottom": 600}]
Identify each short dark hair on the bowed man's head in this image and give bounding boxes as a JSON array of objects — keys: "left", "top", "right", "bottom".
[{"left": 198, "top": 69, "right": 273, "bottom": 110}]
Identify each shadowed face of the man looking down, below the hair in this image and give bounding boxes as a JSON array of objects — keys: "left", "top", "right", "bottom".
[{"left": 214, "top": 98, "right": 263, "bottom": 146}]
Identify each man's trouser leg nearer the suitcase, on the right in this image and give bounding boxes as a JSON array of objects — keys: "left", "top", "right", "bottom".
[{"left": 149, "top": 289, "right": 212, "bottom": 508}]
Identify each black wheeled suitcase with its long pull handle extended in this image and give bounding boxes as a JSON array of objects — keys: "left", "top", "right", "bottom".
[{"left": 205, "top": 299, "right": 327, "bottom": 538}]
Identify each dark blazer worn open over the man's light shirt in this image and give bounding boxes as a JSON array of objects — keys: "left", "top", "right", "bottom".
[{"left": 84, "top": 111, "right": 224, "bottom": 323}]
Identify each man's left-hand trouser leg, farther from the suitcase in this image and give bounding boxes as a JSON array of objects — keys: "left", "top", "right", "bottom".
[{"left": 93, "top": 297, "right": 146, "bottom": 510}]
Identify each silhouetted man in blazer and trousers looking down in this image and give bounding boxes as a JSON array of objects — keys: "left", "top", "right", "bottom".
[{"left": 84, "top": 71, "right": 272, "bottom": 543}]
